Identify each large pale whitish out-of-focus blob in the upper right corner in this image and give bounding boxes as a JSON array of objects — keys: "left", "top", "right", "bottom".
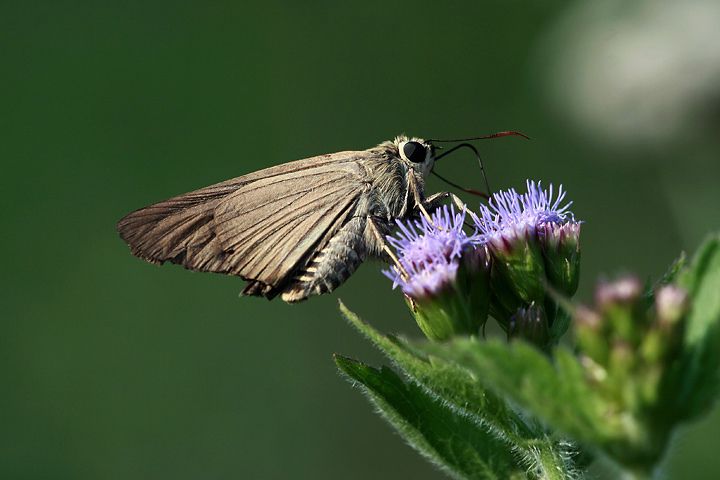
[{"left": 542, "top": 0, "right": 720, "bottom": 146}]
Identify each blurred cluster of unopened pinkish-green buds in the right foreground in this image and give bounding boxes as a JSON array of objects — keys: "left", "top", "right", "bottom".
[{"left": 573, "top": 276, "right": 696, "bottom": 465}]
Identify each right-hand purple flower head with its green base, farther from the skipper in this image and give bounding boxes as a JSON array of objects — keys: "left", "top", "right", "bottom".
[{"left": 475, "top": 180, "right": 581, "bottom": 334}]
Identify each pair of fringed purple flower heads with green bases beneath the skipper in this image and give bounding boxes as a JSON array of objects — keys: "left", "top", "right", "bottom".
[{"left": 385, "top": 181, "right": 580, "bottom": 342}]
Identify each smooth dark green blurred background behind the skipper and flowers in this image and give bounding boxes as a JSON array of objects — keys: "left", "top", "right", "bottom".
[{"left": 0, "top": 0, "right": 720, "bottom": 480}]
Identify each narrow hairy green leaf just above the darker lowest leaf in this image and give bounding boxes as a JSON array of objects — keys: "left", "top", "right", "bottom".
[{"left": 340, "top": 302, "right": 574, "bottom": 478}]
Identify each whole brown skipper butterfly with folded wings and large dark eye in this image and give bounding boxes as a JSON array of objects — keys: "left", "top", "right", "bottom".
[{"left": 118, "top": 136, "right": 434, "bottom": 302}]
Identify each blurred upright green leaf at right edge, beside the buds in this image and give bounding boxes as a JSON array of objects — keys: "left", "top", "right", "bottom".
[{"left": 677, "top": 236, "right": 720, "bottom": 419}]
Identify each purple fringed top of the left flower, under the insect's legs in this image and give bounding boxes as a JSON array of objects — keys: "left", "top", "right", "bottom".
[{"left": 383, "top": 206, "right": 479, "bottom": 299}]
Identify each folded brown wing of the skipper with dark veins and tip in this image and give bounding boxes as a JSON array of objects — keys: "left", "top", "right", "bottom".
[{"left": 117, "top": 152, "right": 368, "bottom": 297}]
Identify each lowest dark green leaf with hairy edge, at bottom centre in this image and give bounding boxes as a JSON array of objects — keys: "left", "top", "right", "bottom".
[{"left": 335, "top": 355, "right": 525, "bottom": 479}]
